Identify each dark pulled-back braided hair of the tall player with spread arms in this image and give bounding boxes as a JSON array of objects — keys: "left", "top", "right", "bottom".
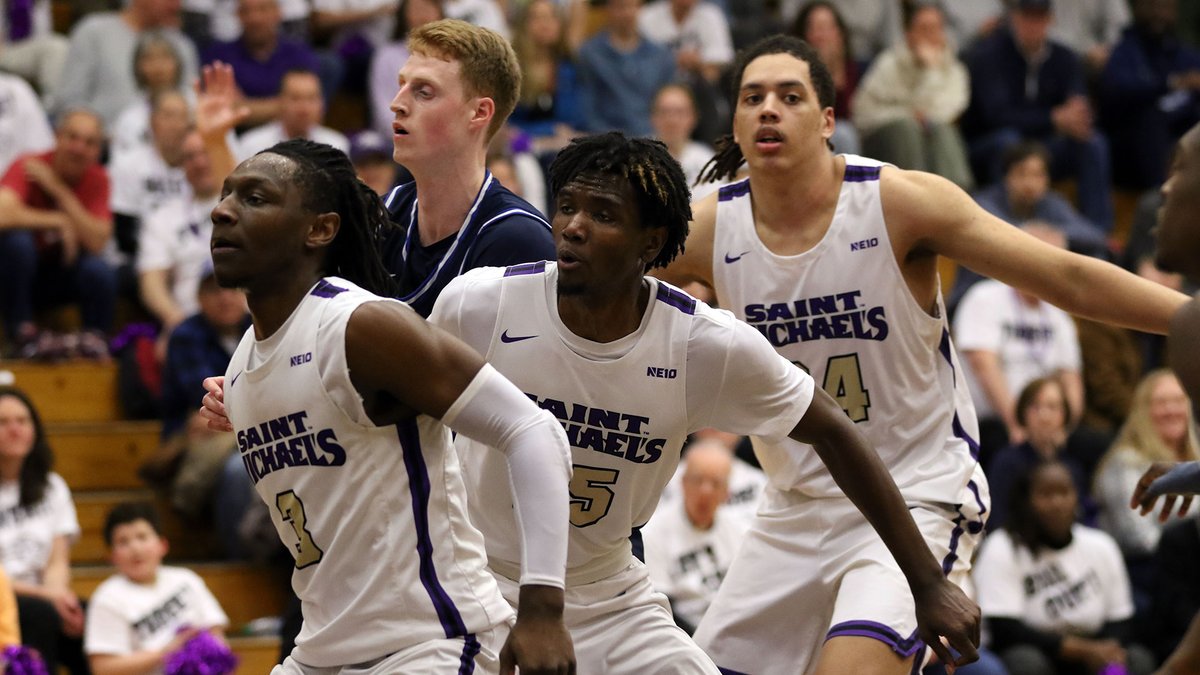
[{"left": 698, "top": 35, "right": 836, "bottom": 183}]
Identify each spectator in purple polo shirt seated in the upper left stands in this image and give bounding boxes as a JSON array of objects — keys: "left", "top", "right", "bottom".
[{"left": 203, "top": 0, "right": 325, "bottom": 126}]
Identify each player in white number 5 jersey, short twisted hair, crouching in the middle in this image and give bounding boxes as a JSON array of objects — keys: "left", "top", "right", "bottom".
[{"left": 430, "top": 133, "right": 979, "bottom": 675}]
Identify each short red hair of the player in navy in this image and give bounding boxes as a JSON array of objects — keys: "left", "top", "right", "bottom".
[{"left": 408, "top": 19, "right": 521, "bottom": 141}]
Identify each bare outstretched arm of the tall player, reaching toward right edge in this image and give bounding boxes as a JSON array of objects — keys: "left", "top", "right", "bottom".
[{"left": 881, "top": 168, "right": 1187, "bottom": 335}]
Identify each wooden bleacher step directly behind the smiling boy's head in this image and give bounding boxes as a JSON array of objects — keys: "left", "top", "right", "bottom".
[{"left": 71, "top": 489, "right": 221, "bottom": 565}]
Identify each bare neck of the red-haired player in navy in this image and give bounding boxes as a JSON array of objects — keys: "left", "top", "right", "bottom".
[{"left": 413, "top": 157, "right": 486, "bottom": 246}]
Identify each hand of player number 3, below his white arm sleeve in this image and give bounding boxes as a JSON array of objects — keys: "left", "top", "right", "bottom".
[{"left": 500, "top": 585, "right": 575, "bottom": 675}]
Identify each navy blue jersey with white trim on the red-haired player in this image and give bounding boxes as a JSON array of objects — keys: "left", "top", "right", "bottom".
[{"left": 382, "top": 172, "right": 556, "bottom": 317}]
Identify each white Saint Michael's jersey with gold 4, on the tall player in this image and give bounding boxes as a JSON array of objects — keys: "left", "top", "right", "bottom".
[{"left": 713, "top": 155, "right": 978, "bottom": 503}]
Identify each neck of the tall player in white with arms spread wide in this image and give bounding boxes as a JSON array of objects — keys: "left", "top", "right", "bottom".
[{"left": 750, "top": 153, "right": 846, "bottom": 229}]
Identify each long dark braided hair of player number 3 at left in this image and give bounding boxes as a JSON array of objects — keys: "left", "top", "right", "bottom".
[{"left": 263, "top": 138, "right": 397, "bottom": 297}]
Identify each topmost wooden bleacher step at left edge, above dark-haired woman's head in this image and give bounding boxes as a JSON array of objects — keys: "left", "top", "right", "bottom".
[{"left": 0, "top": 360, "right": 122, "bottom": 424}]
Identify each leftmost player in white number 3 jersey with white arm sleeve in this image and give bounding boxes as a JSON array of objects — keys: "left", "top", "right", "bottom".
[{"left": 212, "top": 141, "right": 574, "bottom": 675}]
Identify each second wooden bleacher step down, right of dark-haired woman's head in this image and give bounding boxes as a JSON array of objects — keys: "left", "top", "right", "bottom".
[{"left": 47, "top": 422, "right": 162, "bottom": 492}]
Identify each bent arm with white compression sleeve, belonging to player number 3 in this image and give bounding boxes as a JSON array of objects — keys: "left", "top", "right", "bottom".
[{"left": 346, "top": 301, "right": 575, "bottom": 675}]
